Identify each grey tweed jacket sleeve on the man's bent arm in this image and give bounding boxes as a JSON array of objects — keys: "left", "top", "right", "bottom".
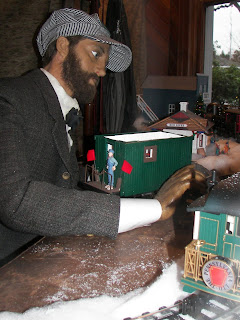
[{"left": 0, "top": 79, "right": 120, "bottom": 238}]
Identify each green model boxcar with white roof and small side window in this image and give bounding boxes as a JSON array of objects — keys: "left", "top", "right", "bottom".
[{"left": 85, "top": 132, "right": 192, "bottom": 197}]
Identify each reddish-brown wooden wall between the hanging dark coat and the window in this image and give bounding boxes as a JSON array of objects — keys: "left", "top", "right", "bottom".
[{"left": 124, "top": 0, "right": 206, "bottom": 93}]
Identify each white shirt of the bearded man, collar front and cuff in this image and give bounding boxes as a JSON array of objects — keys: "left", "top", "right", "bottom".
[{"left": 41, "top": 69, "right": 162, "bottom": 233}]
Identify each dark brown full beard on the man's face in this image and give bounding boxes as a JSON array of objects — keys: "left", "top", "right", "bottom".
[{"left": 62, "top": 47, "right": 99, "bottom": 104}]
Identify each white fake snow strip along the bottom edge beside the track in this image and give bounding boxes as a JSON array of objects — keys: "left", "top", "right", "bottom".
[{"left": 0, "top": 258, "right": 188, "bottom": 320}]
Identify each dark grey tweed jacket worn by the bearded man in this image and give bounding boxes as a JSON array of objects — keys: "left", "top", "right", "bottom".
[{"left": 0, "top": 69, "right": 120, "bottom": 258}]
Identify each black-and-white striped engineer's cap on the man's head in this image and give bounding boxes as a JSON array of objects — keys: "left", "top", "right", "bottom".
[{"left": 37, "top": 8, "right": 132, "bottom": 72}]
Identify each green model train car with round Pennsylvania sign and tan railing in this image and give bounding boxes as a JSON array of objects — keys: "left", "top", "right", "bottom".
[{"left": 182, "top": 173, "right": 240, "bottom": 301}]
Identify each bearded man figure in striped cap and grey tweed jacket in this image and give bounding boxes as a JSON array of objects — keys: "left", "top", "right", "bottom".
[{"left": 0, "top": 9, "right": 205, "bottom": 263}]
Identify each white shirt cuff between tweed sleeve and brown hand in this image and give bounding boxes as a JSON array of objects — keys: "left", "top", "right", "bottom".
[{"left": 118, "top": 198, "right": 162, "bottom": 233}]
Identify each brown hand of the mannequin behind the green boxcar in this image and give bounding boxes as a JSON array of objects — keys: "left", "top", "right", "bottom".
[{"left": 155, "top": 165, "right": 210, "bottom": 220}]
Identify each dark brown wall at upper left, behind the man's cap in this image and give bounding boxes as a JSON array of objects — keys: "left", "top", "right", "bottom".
[{"left": 0, "top": 0, "right": 62, "bottom": 77}]
